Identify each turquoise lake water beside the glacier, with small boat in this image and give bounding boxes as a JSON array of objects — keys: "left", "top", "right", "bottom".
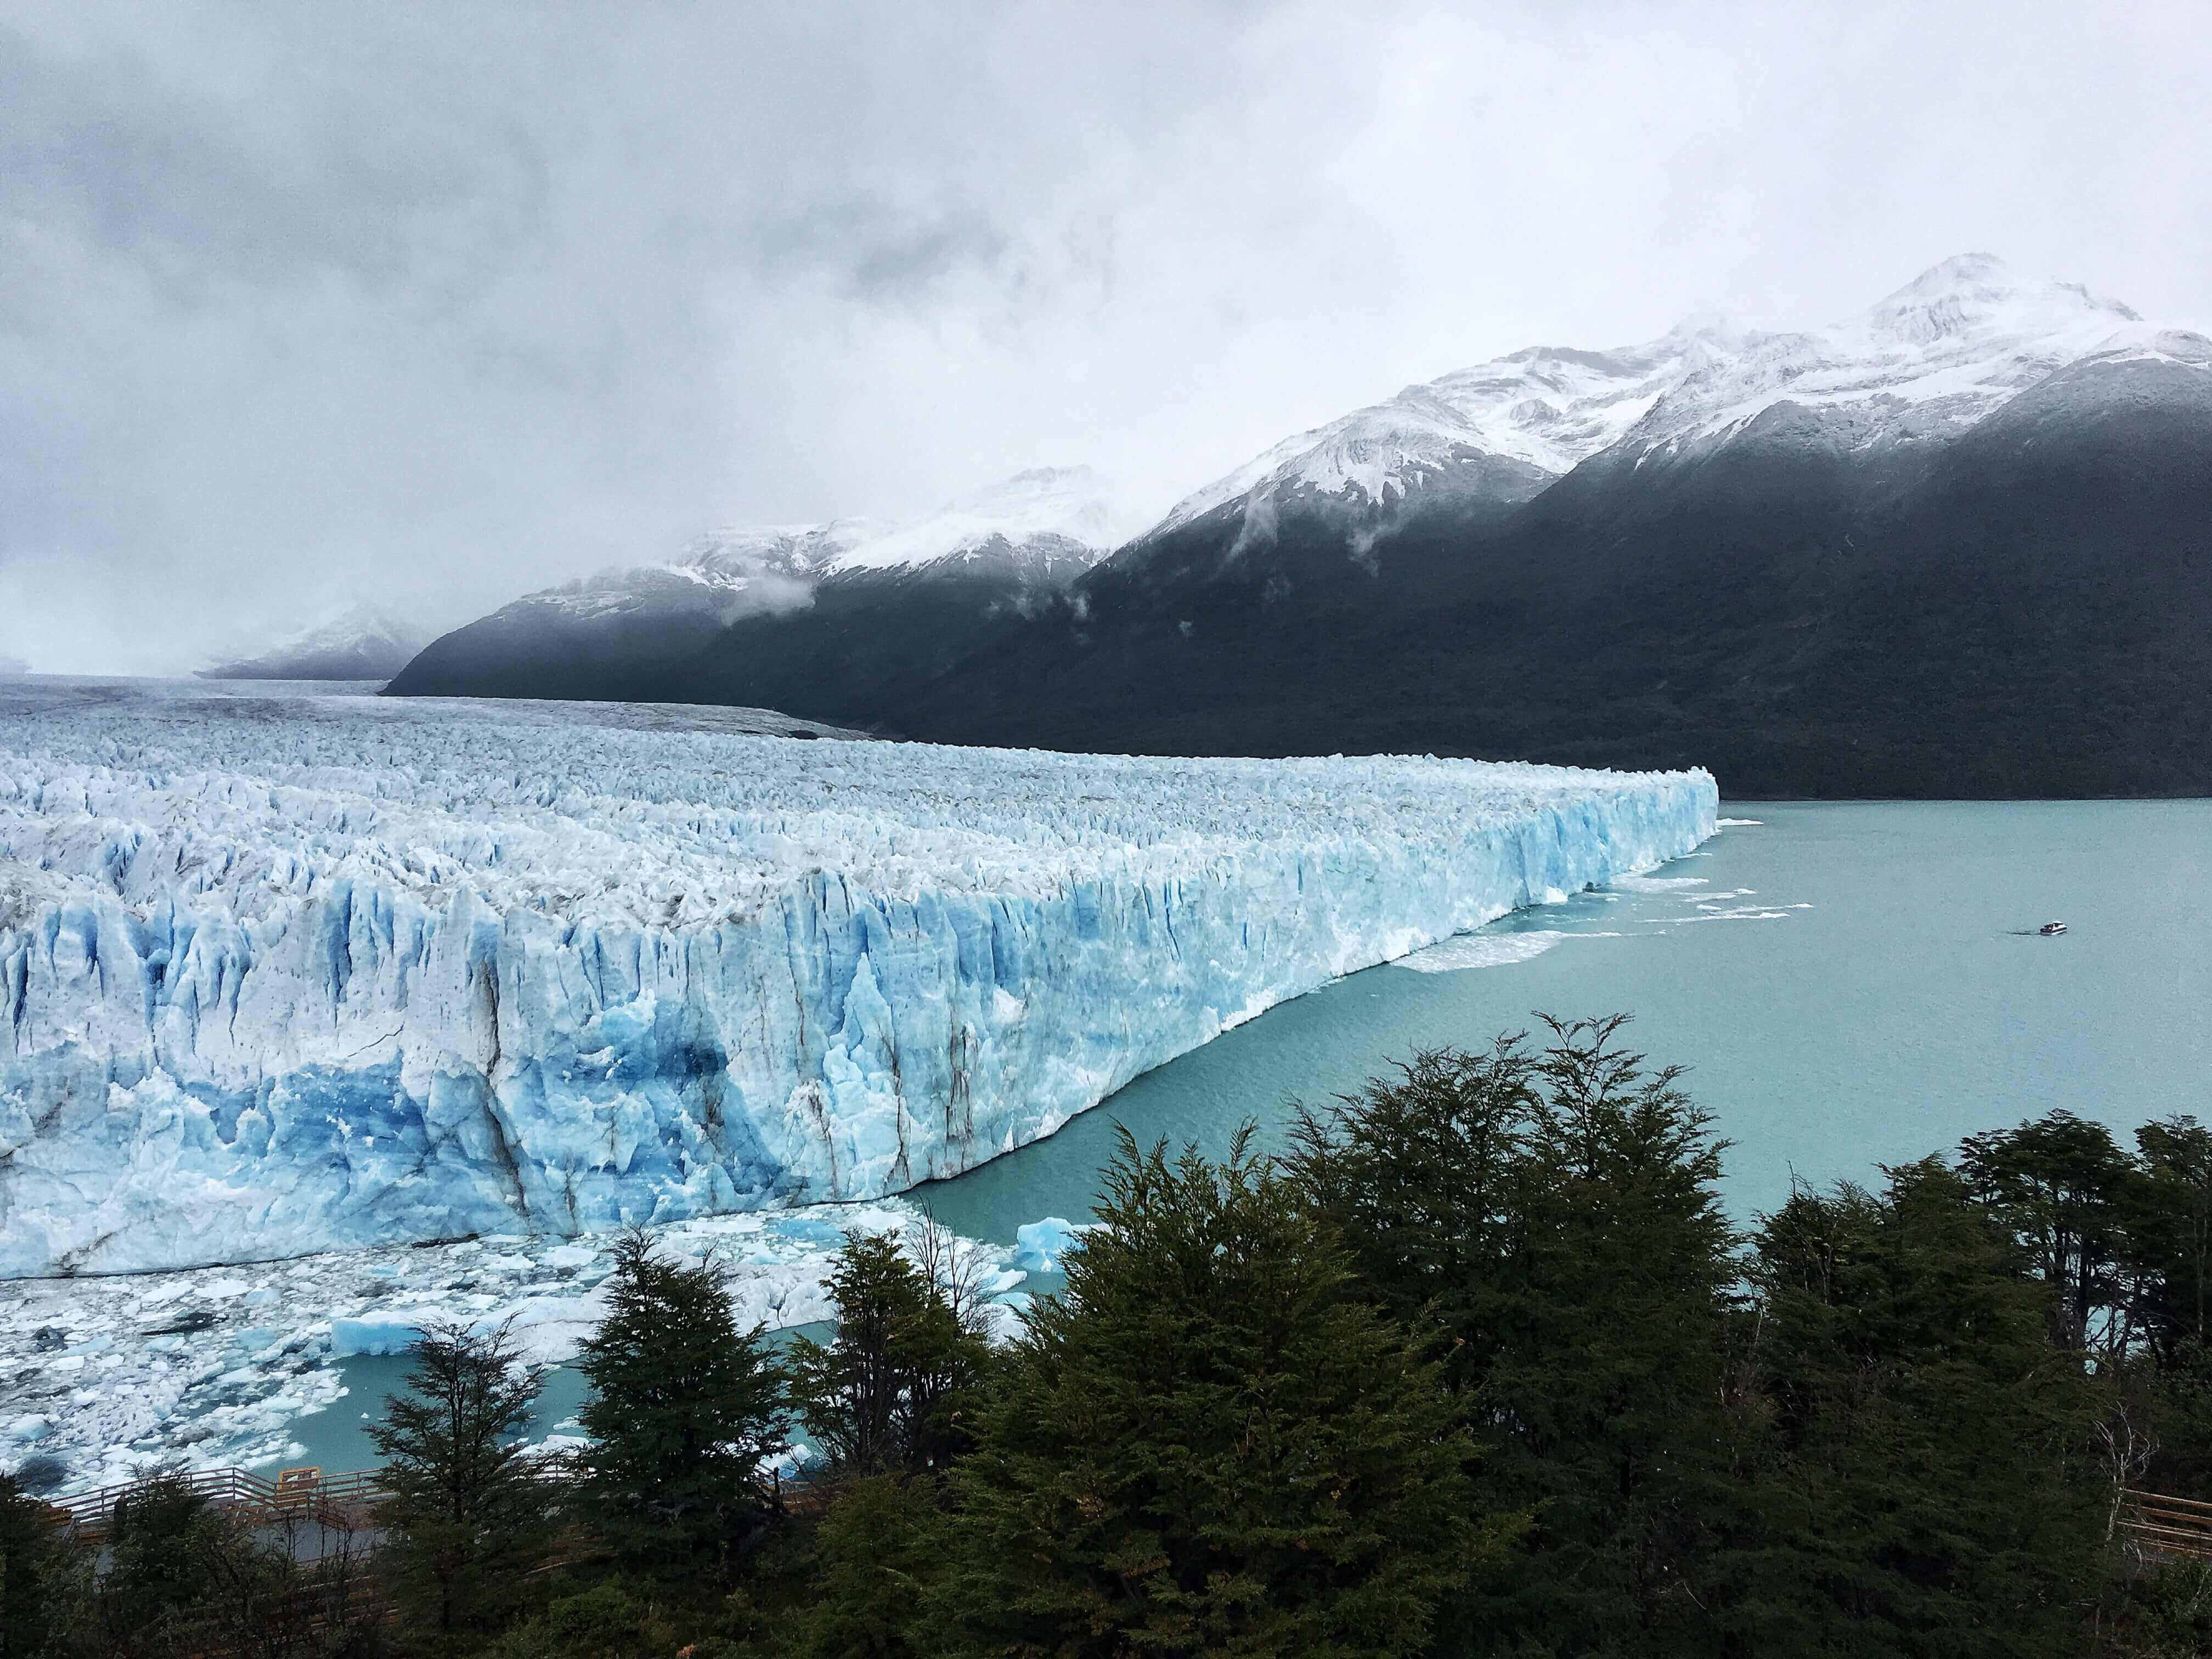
[{"left": 281, "top": 801, "right": 2212, "bottom": 1469}]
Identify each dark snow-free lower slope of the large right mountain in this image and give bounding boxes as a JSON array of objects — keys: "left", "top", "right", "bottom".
[{"left": 889, "top": 352, "right": 2212, "bottom": 797}]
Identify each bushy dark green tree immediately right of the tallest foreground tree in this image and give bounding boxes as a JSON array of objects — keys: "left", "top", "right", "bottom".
[{"left": 1736, "top": 1157, "right": 2108, "bottom": 1659}]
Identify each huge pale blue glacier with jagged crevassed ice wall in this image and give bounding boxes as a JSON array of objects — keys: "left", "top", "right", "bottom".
[{"left": 0, "top": 695, "right": 1717, "bottom": 1276}]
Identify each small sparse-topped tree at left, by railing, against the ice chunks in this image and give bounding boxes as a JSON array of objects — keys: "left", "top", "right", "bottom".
[{"left": 369, "top": 1325, "right": 551, "bottom": 1630}]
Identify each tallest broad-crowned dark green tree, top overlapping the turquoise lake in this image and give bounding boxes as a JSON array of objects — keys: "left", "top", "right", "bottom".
[{"left": 1292, "top": 1018, "right": 1747, "bottom": 1652}]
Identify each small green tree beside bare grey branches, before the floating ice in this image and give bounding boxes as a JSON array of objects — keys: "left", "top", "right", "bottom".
[{"left": 787, "top": 1223, "right": 991, "bottom": 1475}]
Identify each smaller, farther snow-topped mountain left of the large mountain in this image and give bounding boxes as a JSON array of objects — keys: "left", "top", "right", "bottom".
[{"left": 392, "top": 467, "right": 1137, "bottom": 708}]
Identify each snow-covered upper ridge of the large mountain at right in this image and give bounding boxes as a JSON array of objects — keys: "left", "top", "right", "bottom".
[{"left": 1146, "top": 255, "right": 2205, "bottom": 540}]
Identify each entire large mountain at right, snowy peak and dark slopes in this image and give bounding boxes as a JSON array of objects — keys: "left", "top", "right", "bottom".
[{"left": 889, "top": 255, "right": 2212, "bottom": 797}]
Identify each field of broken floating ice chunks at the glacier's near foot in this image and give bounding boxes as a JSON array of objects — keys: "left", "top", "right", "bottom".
[{"left": 0, "top": 1199, "right": 1044, "bottom": 1493}]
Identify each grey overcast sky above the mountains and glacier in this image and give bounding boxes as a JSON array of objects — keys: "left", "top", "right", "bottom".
[{"left": 0, "top": 0, "right": 2212, "bottom": 673}]
